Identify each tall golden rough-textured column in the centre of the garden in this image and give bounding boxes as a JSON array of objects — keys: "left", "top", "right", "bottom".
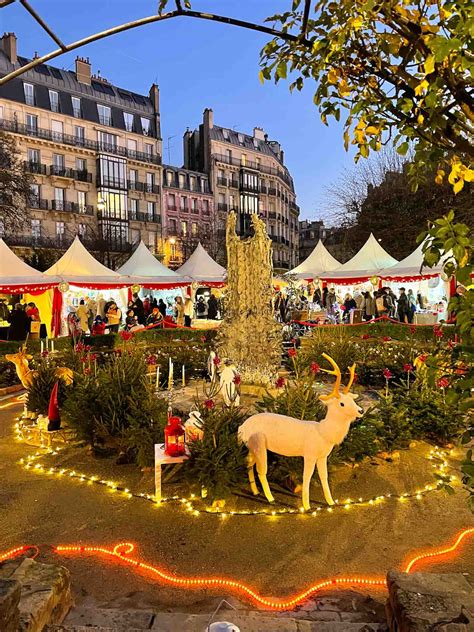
[{"left": 218, "top": 213, "right": 281, "bottom": 385}]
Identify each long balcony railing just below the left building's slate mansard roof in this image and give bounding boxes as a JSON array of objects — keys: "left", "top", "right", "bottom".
[{"left": 0, "top": 119, "right": 161, "bottom": 165}]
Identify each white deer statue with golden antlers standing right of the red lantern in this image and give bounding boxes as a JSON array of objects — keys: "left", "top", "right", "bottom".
[{"left": 238, "top": 353, "right": 362, "bottom": 511}]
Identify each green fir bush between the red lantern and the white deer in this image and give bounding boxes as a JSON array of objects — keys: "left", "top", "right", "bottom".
[{"left": 184, "top": 405, "right": 247, "bottom": 500}]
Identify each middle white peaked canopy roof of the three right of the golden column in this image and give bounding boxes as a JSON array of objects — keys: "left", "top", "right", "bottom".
[{"left": 323, "top": 233, "right": 398, "bottom": 283}]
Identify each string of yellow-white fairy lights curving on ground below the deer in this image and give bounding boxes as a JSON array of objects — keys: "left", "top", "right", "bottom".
[{"left": 15, "top": 422, "right": 458, "bottom": 519}]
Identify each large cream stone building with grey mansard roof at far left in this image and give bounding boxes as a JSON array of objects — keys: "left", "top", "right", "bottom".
[{"left": 0, "top": 33, "right": 162, "bottom": 264}]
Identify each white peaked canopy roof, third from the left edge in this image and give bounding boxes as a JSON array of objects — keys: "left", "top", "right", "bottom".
[{"left": 117, "top": 241, "right": 191, "bottom": 287}]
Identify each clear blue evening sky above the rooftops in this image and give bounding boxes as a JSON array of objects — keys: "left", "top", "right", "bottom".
[{"left": 0, "top": 0, "right": 353, "bottom": 219}]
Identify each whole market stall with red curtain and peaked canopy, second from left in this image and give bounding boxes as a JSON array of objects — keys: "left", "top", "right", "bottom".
[{"left": 45, "top": 237, "right": 130, "bottom": 336}]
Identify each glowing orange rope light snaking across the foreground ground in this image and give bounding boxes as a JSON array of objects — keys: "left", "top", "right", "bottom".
[{"left": 55, "top": 528, "right": 474, "bottom": 610}]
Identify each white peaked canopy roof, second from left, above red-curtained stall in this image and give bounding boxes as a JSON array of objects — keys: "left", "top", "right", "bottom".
[{"left": 45, "top": 236, "right": 129, "bottom": 287}]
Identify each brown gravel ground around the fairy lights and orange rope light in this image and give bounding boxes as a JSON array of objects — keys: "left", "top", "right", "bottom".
[{"left": 0, "top": 400, "right": 474, "bottom": 612}]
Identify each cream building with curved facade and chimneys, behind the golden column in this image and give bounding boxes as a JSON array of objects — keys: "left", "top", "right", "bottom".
[{"left": 183, "top": 109, "right": 299, "bottom": 270}]
